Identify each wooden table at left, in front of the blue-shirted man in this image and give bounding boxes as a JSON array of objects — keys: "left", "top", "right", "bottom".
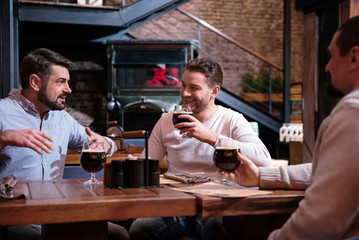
[{"left": 0, "top": 179, "right": 196, "bottom": 239}]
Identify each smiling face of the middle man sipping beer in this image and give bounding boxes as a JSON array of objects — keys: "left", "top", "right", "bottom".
[{"left": 180, "top": 70, "right": 215, "bottom": 114}]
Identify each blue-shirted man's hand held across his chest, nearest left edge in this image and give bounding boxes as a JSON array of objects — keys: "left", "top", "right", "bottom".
[{"left": 0, "top": 128, "right": 54, "bottom": 155}]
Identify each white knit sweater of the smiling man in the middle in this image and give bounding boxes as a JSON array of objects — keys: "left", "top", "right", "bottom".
[{"left": 142, "top": 106, "right": 271, "bottom": 176}]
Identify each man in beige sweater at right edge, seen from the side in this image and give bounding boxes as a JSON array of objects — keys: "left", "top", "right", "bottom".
[{"left": 227, "top": 16, "right": 359, "bottom": 240}]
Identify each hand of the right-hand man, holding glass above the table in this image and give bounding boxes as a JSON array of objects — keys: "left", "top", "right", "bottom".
[{"left": 224, "top": 153, "right": 260, "bottom": 187}]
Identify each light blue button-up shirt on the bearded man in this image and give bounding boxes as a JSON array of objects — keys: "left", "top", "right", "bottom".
[{"left": 0, "top": 89, "right": 116, "bottom": 180}]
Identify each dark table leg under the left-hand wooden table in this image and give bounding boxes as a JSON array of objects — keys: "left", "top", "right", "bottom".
[{"left": 42, "top": 221, "right": 107, "bottom": 240}]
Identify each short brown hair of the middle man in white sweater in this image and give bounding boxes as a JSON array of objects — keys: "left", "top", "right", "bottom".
[{"left": 186, "top": 58, "right": 223, "bottom": 87}]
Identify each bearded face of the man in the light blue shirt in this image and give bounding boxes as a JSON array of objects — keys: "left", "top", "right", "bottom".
[{"left": 38, "top": 65, "right": 71, "bottom": 110}]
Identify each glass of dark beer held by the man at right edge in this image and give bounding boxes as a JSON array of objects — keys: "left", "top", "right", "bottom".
[{"left": 213, "top": 138, "right": 241, "bottom": 185}]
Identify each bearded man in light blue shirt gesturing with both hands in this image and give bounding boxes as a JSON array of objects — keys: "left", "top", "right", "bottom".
[{"left": 0, "top": 48, "right": 129, "bottom": 239}]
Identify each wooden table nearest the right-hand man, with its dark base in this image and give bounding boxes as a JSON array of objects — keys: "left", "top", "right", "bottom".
[{"left": 195, "top": 188, "right": 304, "bottom": 240}]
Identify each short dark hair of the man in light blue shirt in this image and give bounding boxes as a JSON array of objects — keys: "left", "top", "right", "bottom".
[{"left": 20, "top": 48, "right": 72, "bottom": 89}]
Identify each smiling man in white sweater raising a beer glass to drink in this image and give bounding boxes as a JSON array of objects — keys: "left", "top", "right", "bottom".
[{"left": 130, "top": 58, "right": 272, "bottom": 240}]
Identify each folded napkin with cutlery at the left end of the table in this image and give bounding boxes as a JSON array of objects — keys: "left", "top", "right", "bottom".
[{"left": 0, "top": 176, "right": 29, "bottom": 199}]
